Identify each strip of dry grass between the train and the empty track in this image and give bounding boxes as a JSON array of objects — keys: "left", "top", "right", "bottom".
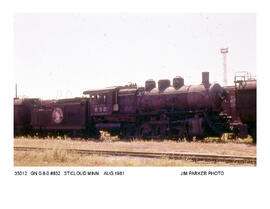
[{"left": 14, "top": 137, "right": 256, "bottom": 156}]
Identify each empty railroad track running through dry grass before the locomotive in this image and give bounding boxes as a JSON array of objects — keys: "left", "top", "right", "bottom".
[{"left": 14, "top": 147, "right": 257, "bottom": 164}]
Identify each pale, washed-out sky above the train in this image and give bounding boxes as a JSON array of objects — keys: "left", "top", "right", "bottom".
[{"left": 14, "top": 13, "right": 256, "bottom": 99}]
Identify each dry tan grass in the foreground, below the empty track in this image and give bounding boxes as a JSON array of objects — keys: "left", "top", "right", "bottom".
[{"left": 14, "top": 149, "right": 249, "bottom": 167}]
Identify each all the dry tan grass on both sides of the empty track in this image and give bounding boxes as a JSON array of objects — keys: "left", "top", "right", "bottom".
[{"left": 14, "top": 137, "right": 256, "bottom": 166}]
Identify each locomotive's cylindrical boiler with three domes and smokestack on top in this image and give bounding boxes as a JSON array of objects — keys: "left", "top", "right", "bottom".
[{"left": 138, "top": 72, "right": 226, "bottom": 112}]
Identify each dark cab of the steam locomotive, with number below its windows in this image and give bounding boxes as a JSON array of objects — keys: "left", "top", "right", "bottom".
[{"left": 83, "top": 85, "right": 137, "bottom": 136}]
